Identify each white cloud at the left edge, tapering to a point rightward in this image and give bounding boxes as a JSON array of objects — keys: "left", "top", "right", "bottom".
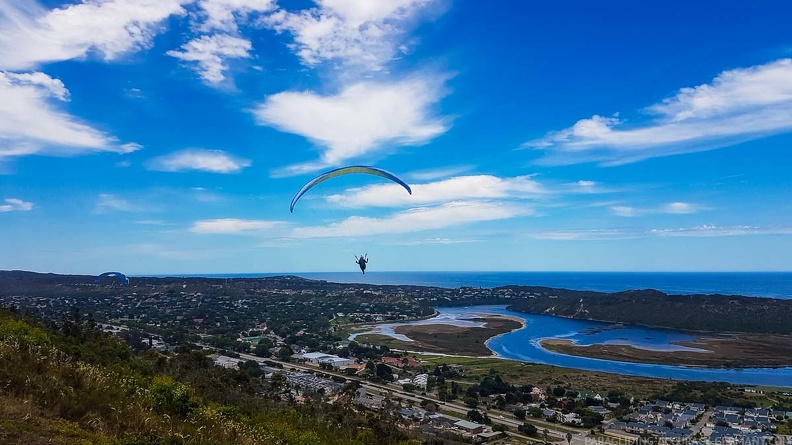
[{"left": 0, "top": 71, "right": 140, "bottom": 158}]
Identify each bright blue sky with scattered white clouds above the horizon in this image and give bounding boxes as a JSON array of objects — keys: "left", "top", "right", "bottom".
[{"left": 0, "top": 0, "right": 792, "bottom": 275}]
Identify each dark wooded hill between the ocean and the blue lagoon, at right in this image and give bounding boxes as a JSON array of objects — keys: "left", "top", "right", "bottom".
[{"left": 504, "top": 286, "right": 792, "bottom": 334}]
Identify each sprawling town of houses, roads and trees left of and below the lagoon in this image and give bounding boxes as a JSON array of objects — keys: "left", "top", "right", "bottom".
[{"left": 0, "top": 270, "right": 792, "bottom": 445}]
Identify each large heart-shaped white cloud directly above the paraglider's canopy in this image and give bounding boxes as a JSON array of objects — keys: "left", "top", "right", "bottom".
[{"left": 254, "top": 77, "right": 448, "bottom": 174}]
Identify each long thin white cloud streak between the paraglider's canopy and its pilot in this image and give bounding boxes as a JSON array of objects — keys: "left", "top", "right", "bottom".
[{"left": 291, "top": 201, "right": 531, "bottom": 239}]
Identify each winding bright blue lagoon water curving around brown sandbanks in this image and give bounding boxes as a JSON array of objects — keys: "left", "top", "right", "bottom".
[{"left": 364, "top": 306, "right": 792, "bottom": 386}]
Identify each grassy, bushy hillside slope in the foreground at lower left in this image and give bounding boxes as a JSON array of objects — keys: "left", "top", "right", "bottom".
[{"left": 0, "top": 310, "right": 418, "bottom": 445}]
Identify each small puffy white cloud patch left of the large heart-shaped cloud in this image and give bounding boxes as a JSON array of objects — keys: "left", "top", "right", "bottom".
[{"left": 167, "top": 34, "right": 252, "bottom": 84}]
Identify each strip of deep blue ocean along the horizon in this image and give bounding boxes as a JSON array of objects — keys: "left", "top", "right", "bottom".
[{"left": 188, "top": 271, "right": 792, "bottom": 299}]
